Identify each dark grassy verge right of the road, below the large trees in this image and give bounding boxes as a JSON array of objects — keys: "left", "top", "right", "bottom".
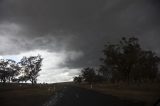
[{"left": 78, "top": 83, "right": 160, "bottom": 106}]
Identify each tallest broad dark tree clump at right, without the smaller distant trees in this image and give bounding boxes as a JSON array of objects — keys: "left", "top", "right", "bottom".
[{"left": 101, "top": 37, "right": 160, "bottom": 82}]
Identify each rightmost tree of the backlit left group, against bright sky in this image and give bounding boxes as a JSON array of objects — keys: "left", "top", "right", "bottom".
[{"left": 20, "top": 55, "right": 43, "bottom": 84}]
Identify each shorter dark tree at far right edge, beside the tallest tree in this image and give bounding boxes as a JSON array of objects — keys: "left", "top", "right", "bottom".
[{"left": 131, "top": 51, "right": 160, "bottom": 82}]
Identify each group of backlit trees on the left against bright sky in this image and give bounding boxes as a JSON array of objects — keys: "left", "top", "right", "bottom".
[{"left": 0, "top": 55, "right": 43, "bottom": 84}]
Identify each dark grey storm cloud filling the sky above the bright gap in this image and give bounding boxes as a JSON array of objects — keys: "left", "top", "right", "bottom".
[{"left": 0, "top": 0, "right": 160, "bottom": 82}]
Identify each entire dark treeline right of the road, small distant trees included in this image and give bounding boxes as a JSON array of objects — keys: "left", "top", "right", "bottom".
[{"left": 74, "top": 37, "right": 160, "bottom": 83}]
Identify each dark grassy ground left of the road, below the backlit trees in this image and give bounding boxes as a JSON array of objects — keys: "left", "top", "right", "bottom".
[{"left": 0, "top": 84, "right": 63, "bottom": 106}]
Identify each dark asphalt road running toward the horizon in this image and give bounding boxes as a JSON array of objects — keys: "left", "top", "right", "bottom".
[{"left": 43, "top": 86, "right": 144, "bottom": 106}]
